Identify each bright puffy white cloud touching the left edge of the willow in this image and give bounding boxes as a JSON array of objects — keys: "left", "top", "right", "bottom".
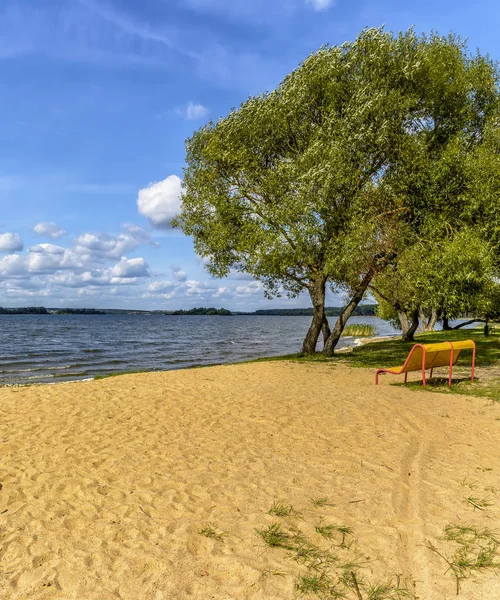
[{"left": 137, "top": 175, "right": 182, "bottom": 229}]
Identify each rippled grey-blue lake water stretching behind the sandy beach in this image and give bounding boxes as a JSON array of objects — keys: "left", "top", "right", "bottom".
[{"left": 0, "top": 315, "right": 468, "bottom": 384}]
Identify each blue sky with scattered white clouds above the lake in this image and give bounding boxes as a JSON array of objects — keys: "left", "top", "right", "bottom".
[{"left": 0, "top": 0, "right": 500, "bottom": 310}]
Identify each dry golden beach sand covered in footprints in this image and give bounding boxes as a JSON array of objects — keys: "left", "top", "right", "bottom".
[{"left": 0, "top": 362, "right": 500, "bottom": 600}]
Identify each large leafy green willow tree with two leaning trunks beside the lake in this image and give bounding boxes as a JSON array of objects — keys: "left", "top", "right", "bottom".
[{"left": 174, "top": 29, "right": 496, "bottom": 355}]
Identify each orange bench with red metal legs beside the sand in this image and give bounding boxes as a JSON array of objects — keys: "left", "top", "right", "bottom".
[{"left": 375, "top": 340, "right": 476, "bottom": 387}]
